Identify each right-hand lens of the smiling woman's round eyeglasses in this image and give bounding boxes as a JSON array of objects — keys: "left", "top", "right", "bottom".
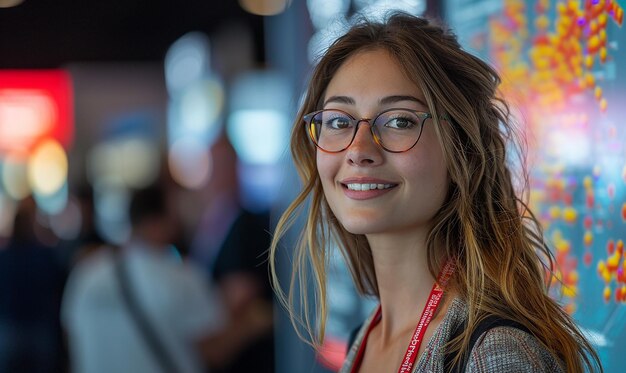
[{"left": 374, "top": 109, "right": 428, "bottom": 152}]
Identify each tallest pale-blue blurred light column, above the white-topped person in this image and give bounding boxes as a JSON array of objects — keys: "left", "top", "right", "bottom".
[{"left": 165, "top": 32, "right": 225, "bottom": 189}]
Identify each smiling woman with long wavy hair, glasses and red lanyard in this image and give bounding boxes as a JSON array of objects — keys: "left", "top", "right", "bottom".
[{"left": 271, "top": 14, "right": 602, "bottom": 373}]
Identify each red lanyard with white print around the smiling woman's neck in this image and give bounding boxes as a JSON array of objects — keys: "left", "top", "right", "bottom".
[{"left": 351, "top": 261, "right": 454, "bottom": 373}]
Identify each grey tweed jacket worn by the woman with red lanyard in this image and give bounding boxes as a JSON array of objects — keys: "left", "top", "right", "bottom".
[{"left": 340, "top": 298, "right": 563, "bottom": 373}]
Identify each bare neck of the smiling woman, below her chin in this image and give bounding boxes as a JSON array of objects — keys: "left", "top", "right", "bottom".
[{"left": 368, "top": 230, "right": 435, "bottom": 343}]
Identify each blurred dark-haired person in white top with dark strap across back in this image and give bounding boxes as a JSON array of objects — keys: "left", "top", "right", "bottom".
[{"left": 62, "top": 187, "right": 265, "bottom": 373}]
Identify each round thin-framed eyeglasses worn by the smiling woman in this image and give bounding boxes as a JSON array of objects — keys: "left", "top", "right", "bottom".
[{"left": 304, "top": 109, "right": 432, "bottom": 153}]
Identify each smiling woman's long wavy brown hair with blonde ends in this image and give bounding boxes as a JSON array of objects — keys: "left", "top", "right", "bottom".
[{"left": 270, "top": 13, "right": 602, "bottom": 372}]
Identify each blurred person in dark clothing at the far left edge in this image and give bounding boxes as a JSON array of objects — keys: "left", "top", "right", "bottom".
[{"left": 0, "top": 197, "right": 65, "bottom": 373}]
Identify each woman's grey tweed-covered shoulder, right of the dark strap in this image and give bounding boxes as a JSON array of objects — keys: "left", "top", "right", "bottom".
[{"left": 467, "top": 326, "right": 563, "bottom": 373}]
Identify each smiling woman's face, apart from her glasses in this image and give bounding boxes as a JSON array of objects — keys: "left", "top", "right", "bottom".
[{"left": 317, "top": 50, "right": 448, "bottom": 235}]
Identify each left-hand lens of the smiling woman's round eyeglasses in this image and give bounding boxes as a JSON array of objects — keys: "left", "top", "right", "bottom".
[{"left": 309, "top": 110, "right": 354, "bottom": 152}]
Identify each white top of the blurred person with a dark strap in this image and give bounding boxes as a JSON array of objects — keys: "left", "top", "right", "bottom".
[{"left": 61, "top": 243, "right": 224, "bottom": 373}]
